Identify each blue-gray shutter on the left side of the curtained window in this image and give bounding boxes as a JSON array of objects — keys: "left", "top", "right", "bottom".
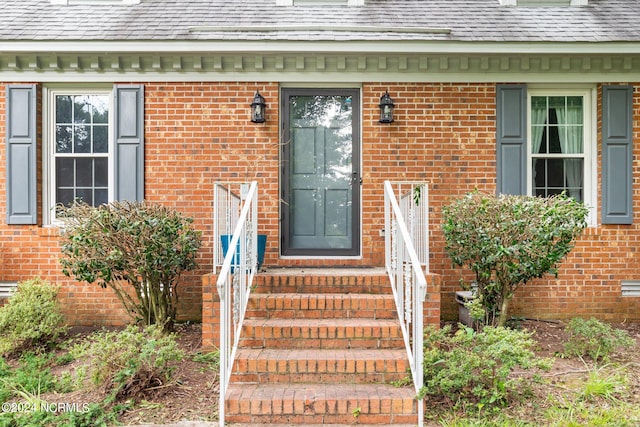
[{"left": 496, "top": 85, "right": 527, "bottom": 194}]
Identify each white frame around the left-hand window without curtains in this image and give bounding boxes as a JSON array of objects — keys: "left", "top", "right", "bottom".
[{"left": 42, "top": 86, "right": 115, "bottom": 227}]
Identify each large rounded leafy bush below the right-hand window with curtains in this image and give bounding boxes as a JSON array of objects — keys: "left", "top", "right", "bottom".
[{"left": 442, "top": 192, "right": 588, "bottom": 326}]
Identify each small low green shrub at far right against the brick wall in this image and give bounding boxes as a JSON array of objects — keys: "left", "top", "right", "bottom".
[{"left": 564, "top": 317, "right": 635, "bottom": 362}]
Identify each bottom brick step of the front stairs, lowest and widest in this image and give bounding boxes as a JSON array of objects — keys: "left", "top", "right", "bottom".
[{"left": 226, "top": 384, "right": 417, "bottom": 425}]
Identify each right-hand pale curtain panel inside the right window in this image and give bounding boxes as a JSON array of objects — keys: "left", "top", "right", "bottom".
[{"left": 556, "top": 102, "right": 583, "bottom": 200}]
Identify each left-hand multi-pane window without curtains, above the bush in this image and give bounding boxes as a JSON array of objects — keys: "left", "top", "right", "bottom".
[{"left": 45, "top": 90, "right": 113, "bottom": 221}]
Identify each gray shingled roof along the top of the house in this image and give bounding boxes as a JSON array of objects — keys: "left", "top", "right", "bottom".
[{"left": 0, "top": 0, "right": 640, "bottom": 43}]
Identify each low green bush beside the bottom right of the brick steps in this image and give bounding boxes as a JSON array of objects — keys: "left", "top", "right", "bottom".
[{"left": 421, "top": 325, "right": 548, "bottom": 408}]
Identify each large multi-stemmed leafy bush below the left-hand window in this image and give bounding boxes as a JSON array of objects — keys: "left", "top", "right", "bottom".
[{"left": 61, "top": 202, "right": 201, "bottom": 330}]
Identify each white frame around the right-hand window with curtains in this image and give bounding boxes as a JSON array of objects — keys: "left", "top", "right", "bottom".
[{"left": 527, "top": 86, "right": 598, "bottom": 226}]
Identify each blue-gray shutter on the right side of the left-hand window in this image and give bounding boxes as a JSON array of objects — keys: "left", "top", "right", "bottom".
[{"left": 114, "top": 85, "right": 144, "bottom": 201}]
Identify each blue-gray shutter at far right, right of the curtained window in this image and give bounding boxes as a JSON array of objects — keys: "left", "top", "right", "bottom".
[{"left": 602, "top": 86, "right": 633, "bottom": 224}]
